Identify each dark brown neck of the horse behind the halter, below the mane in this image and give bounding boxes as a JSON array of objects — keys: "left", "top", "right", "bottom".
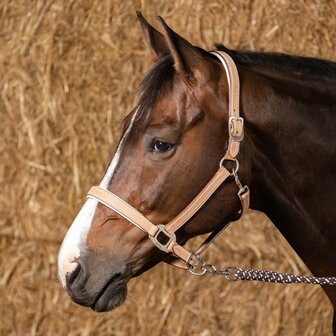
[{"left": 240, "top": 64, "right": 336, "bottom": 275}]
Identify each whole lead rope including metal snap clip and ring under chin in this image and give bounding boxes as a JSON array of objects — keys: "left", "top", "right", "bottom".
[{"left": 188, "top": 254, "right": 336, "bottom": 286}]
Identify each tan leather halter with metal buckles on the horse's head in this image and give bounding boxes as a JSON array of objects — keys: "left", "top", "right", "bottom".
[{"left": 87, "top": 51, "right": 250, "bottom": 268}]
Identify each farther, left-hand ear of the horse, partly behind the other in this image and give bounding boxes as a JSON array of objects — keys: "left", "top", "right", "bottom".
[{"left": 136, "top": 11, "right": 170, "bottom": 61}]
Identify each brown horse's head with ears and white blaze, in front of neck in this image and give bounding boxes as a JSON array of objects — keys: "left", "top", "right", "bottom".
[{"left": 58, "top": 13, "right": 249, "bottom": 311}]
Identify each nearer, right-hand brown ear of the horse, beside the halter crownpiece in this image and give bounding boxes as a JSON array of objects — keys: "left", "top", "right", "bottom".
[{"left": 157, "top": 16, "right": 208, "bottom": 77}]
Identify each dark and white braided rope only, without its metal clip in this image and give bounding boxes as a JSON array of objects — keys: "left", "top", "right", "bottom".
[{"left": 230, "top": 268, "right": 336, "bottom": 285}]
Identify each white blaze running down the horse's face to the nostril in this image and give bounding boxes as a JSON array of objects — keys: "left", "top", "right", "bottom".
[{"left": 58, "top": 107, "right": 139, "bottom": 287}]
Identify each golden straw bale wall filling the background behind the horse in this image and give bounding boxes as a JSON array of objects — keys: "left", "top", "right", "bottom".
[{"left": 0, "top": 0, "right": 336, "bottom": 336}]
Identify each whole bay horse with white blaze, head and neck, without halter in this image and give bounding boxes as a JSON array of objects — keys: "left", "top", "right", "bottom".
[{"left": 58, "top": 13, "right": 336, "bottom": 330}]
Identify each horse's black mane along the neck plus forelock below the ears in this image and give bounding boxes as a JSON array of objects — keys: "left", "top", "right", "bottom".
[{"left": 138, "top": 44, "right": 336, "bottom": 118}]
